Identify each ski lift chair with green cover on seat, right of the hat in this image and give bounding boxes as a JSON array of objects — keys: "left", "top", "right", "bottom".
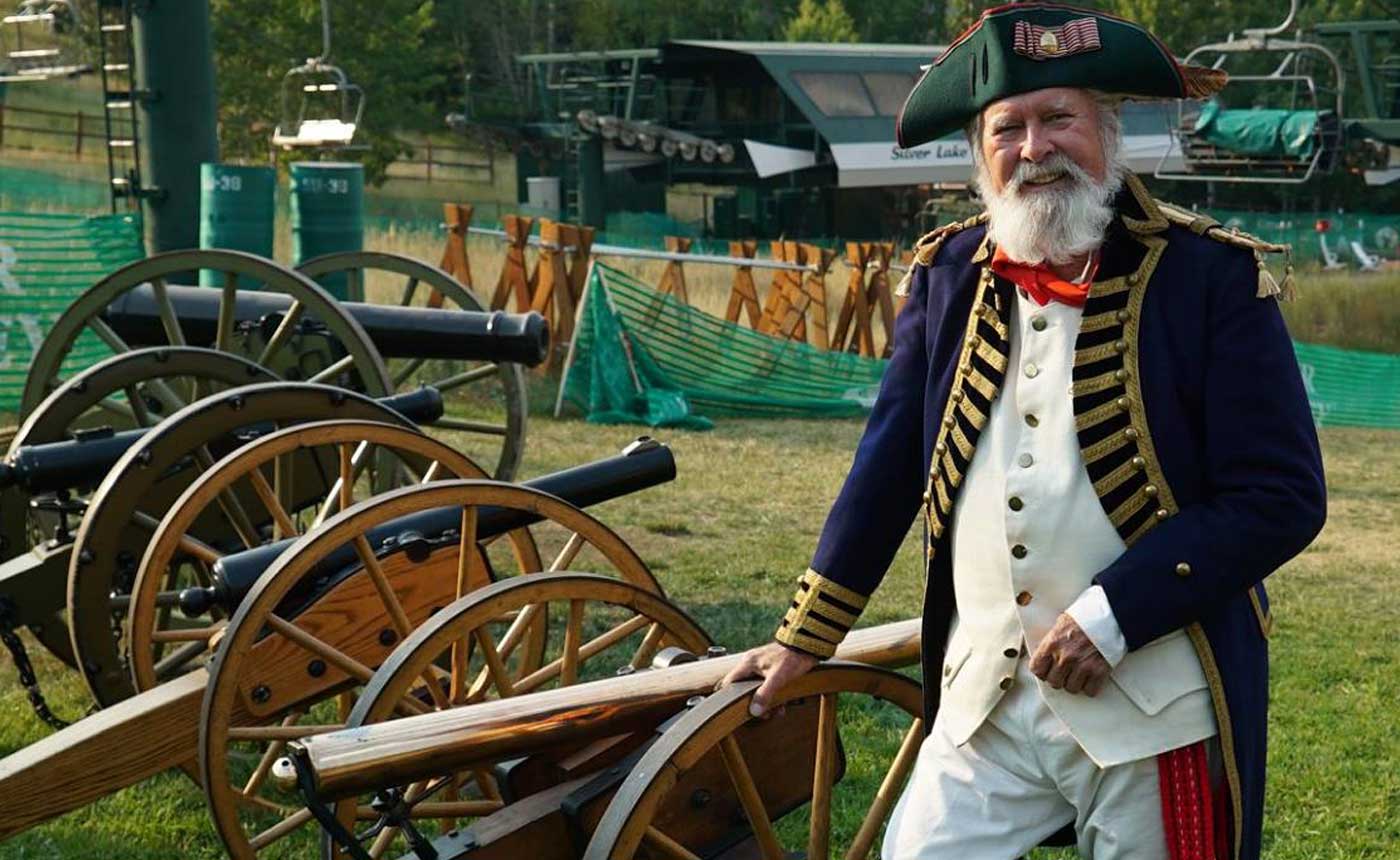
[{"left": 1155, "top": 0, "right": 1347, "bottom": 183}]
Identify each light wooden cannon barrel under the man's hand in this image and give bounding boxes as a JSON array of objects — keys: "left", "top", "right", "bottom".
[{"left": 288, "top": 618, "right": 923, "bottom": 801}]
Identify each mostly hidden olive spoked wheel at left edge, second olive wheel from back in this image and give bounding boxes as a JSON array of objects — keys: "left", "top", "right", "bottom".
[{"left": 0, "top": 347, "right": 276, "bottom": 667}]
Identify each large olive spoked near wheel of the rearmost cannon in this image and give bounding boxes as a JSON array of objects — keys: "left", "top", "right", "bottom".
[{"left": 21, "top": 251, "right": 392, "bottom": 415}]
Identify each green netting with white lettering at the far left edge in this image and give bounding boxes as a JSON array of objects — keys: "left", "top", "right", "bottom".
[{"left": 0, "top": 213, "right": 143, "bottom": 412}]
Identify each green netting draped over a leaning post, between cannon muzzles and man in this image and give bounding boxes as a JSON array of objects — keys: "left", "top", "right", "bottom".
[{"left": 560, "top": 263, "right": 886, "bottom": 429}]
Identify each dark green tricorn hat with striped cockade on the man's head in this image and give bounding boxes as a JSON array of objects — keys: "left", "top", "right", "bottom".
[{"left": 895, "top": 3, "right": 1228, "bottom": 148}]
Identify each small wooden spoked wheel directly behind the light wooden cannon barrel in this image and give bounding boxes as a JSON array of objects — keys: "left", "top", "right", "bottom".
[{"left": 328, "top": 573, "right": 711, "bottom": 859}]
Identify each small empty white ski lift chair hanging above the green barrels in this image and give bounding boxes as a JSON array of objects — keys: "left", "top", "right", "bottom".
[{"left": 272, "top": 59, "right": 364, "bottom": 150}]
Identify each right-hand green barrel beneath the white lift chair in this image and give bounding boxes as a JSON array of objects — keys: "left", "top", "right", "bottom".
[{"left": 291, "top": 161, "right": 364, "bottom": 301}]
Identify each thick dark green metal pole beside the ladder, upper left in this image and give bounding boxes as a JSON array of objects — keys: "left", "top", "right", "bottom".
[{"left": 132, "top": 0, "right": 218, "bottom": 254}]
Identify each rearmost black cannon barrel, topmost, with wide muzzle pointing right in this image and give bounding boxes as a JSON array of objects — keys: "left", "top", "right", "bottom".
[{"left": 102, "top": 284, "right": 549, "bottom": 367}]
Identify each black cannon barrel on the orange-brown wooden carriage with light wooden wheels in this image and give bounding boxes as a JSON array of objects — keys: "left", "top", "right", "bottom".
[{"left": 200, "top": 437, "right": 676, "bottom": 615}]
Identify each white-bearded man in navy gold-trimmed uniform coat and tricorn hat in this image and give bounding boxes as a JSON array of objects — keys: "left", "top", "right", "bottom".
[{"left": 725, "top": 3, "right": 1326, "bottom": 860}]
